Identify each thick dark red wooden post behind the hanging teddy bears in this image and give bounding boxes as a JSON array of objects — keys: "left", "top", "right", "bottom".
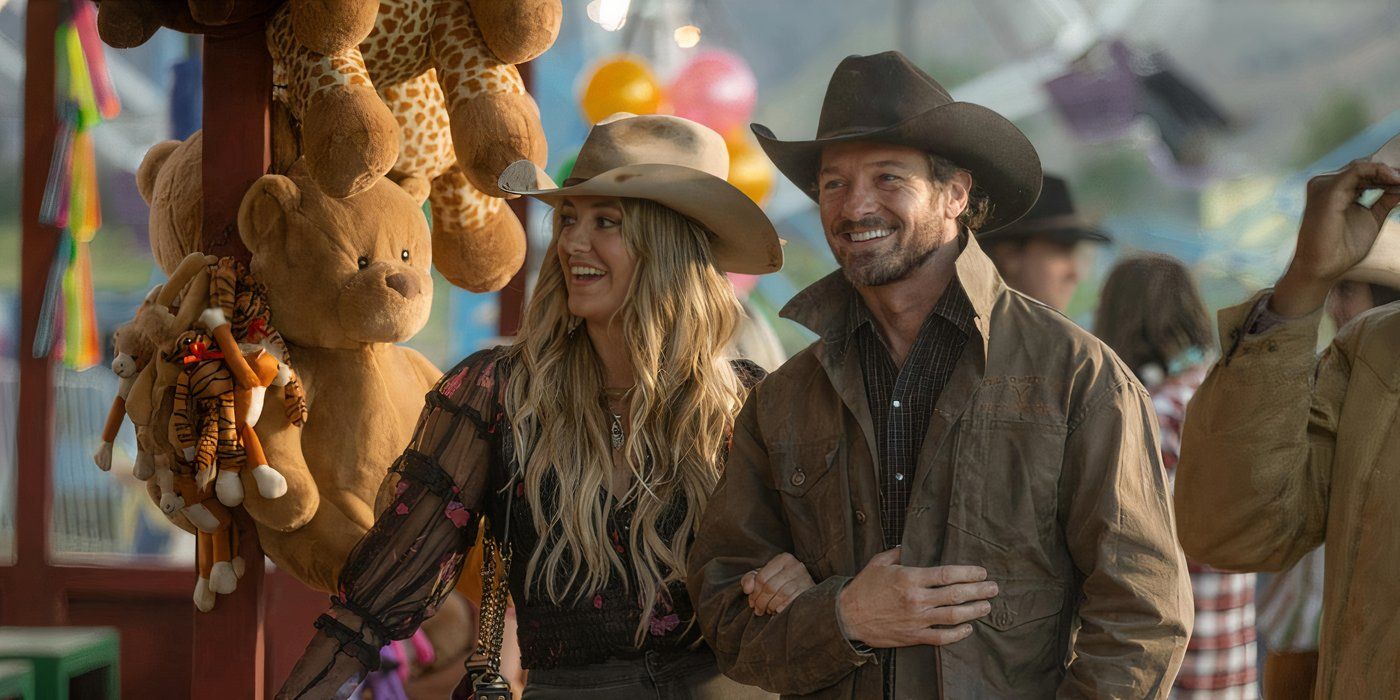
[{"left": 190, "top": 21, "right": 272, "bottom": 700}]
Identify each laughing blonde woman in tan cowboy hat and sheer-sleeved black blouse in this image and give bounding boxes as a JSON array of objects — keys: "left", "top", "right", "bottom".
[{"left": 283, "top": 115, "right": 783, "bottom": 699}]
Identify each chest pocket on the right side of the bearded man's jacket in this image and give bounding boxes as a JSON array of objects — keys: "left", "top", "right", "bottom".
[{"left": 948, "top": 419, "right": 1065, "bottom": 560}]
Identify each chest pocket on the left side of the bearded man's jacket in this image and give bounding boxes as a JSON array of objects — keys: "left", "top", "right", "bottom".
[{"left": 769, "top": 438, "right": 848, "bottom": 568}]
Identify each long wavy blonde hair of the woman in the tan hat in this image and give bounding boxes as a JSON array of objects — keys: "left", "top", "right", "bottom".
[{"left": 505, "top": 199, "right": 745, "bottom": 645}]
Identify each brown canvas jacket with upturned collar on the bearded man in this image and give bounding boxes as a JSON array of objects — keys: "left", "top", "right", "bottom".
[{"left": 689, "top": 237, "right": 1193, "bottom": 699}]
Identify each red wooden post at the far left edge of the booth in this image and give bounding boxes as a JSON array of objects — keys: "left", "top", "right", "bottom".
[{"left": 0, "top": 0, "right": 63, "bottom": 624}]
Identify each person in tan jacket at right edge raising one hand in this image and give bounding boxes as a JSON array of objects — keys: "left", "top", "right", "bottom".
[{"left": 1176, "top": 161, "right": 1400, "bottom": 697}]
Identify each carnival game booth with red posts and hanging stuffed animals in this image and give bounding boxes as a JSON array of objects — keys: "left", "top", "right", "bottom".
[{"left": 0, "top": 0, "right": 561, "bottom": 699}]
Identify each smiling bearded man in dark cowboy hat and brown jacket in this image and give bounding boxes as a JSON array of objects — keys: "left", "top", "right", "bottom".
[{"left": 689, "top": 52, "right": 1191, "bottom": 699}]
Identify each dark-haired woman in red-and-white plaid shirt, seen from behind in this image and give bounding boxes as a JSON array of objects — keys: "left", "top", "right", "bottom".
[{"left": 1093, "top": 255, "right": 1259, "bottom": 699}]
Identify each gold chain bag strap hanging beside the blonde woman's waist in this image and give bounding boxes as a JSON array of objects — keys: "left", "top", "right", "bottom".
[{"left": 452, "top": 486, "right": 515, "bottom": 700}]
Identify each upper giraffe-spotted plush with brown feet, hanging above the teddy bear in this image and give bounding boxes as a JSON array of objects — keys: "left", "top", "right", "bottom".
[{"left": 267, "top": 0, "right": 563, "bottom": 197}]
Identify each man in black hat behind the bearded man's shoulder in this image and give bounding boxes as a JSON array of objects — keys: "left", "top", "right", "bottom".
[{"left": 977, "top": 175, "right": 1113, "bottom": 311}]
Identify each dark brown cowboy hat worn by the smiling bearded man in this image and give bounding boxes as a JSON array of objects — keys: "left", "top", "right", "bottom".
[{"left": 750, "top": 50, "right": 1040, "bottom": 231}]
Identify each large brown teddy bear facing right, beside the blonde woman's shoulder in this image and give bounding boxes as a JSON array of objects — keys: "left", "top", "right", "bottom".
[{"left": 229, "top": 165, "right": 441, "bottom": 591}]
